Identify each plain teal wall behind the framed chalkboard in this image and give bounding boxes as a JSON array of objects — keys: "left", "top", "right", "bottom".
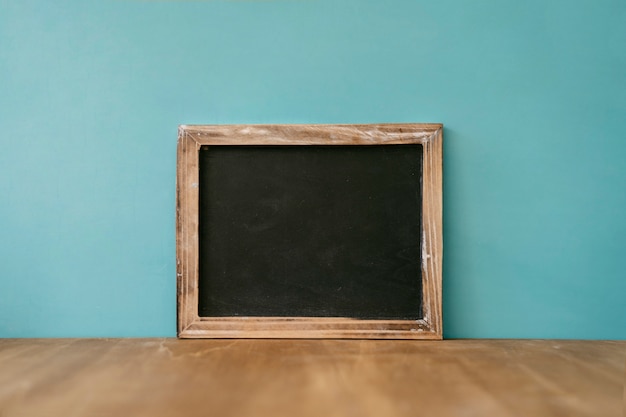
[{"left": 0, "top": 0, "right": 626, "bottom": 339}]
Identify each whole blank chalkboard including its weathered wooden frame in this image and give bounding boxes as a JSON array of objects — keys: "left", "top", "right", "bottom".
[{"left": 177, "top": 124, "right": 442, "bottom": 339}]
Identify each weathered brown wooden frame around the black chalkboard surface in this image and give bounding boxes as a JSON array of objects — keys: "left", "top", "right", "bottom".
[{"left": 176, "top": 124, "right": 443, "bottom": 339}]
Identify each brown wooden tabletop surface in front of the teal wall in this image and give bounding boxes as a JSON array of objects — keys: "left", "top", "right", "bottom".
[{"left": 0, "top": 339, "right": 626, "bottom": 417}]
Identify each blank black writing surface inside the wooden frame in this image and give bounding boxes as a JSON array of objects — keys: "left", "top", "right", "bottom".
[{"left": 198, "top": 144, "right": 422, "bottom": 320}]
